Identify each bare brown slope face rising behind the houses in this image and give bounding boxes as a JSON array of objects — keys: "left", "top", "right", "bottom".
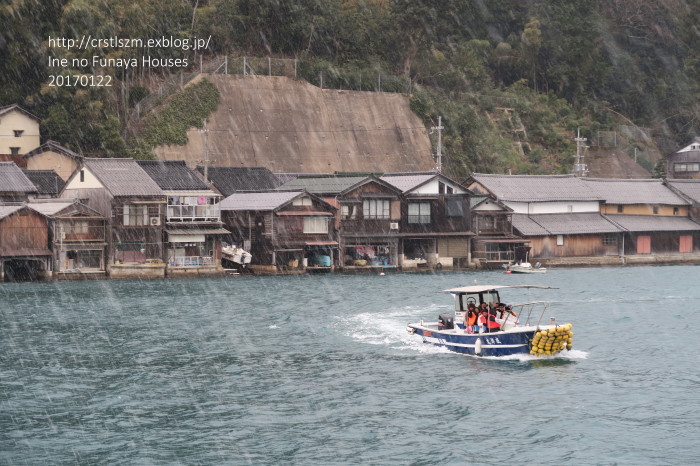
[{"left": 154, "top": 74, "right": 434, "bottom": 173}]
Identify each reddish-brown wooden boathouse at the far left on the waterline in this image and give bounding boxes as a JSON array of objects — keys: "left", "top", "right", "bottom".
[{"left": 0, "top": 205, "right": 51, "bottom": 281}]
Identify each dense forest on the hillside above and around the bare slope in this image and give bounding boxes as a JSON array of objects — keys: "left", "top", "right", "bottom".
[{"left": 0, "top": 0, "right": 700, "bottom": 173}]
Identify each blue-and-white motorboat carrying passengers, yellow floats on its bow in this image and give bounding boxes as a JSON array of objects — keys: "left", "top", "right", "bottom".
[{"left": 406, "top": 285, "right": 573, "bottom": 356}]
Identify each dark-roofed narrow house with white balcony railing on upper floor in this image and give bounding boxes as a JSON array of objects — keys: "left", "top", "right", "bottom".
[{"left": 138, "top": 161, "right": 229, "bottom": 276}]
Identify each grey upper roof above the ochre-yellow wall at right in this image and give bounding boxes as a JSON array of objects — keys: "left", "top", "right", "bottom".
[{"left": 582, "top": 178, "right": 688, "bottom": 205}]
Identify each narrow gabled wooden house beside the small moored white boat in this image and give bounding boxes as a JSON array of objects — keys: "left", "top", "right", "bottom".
[{"left": 470, "top": 194, "right": 530, "bottom": 268}]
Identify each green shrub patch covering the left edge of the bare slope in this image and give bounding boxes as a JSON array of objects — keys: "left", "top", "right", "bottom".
[{"left": 133, "top": 79, "right": 219, "bottom": 159}]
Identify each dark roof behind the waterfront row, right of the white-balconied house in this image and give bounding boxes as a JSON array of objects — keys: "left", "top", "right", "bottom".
[{"left": 197, "top": 166, "right": 281, "bottom": 196}]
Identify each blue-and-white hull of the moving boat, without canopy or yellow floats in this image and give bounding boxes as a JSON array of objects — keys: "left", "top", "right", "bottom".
[{"left": 407, "top": 324, "right": 537, "bottom": 356}]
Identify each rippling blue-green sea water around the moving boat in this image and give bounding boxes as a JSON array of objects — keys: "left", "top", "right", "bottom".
[{"left": 0, "top": 266, "right": 700, "bottom": 465}]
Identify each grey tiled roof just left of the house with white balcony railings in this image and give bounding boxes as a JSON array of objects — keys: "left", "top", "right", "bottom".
[{"left": 84, "top": 159, "right": 164, "bottom": 196}]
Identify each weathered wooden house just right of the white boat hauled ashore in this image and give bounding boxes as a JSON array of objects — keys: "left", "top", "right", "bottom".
[{"left": 221, "top": 191, "right": 338, "bottom": 270}]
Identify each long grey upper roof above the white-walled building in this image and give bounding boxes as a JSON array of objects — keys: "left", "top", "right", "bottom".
[{"left": 472, "top": 173, "right": 601, "bottom": 202}]
